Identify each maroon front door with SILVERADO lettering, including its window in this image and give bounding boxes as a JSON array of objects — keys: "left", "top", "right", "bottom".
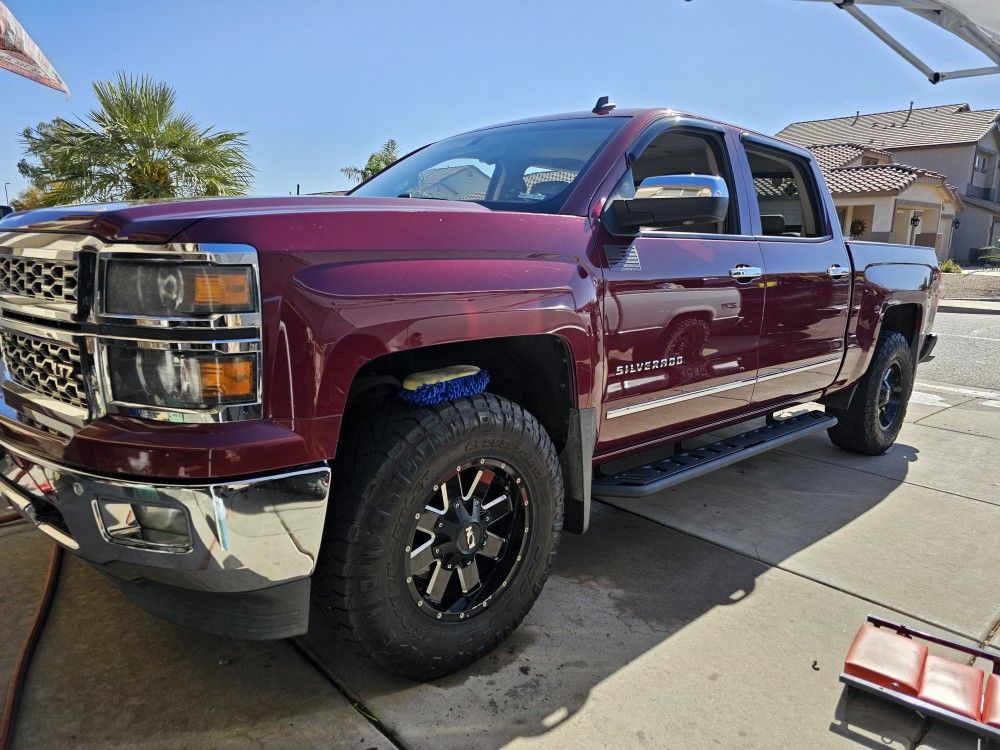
[{"left": 599, "top": 122, "right": 764, "bottom": 451}]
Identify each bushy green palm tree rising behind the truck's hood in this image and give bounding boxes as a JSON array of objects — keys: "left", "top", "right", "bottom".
[{"left": 17, "top": 73, "right": 253, "bottom": 205}]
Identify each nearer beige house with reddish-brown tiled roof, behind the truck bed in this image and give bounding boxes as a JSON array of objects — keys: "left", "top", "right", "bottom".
[{"left": 811, "top": 143, "right": 965, "bottom": 260}]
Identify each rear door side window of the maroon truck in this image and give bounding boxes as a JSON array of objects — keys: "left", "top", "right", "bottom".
[{"left": 746, "top": 144, "right": 827, "bottom": 237}]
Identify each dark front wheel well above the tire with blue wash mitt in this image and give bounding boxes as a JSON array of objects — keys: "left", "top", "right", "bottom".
[{"left": 344, "top": 334, "right": 576, "bottom": 451}]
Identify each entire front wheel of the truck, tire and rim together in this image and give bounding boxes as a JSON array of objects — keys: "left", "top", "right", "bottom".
[{"left": 314, "top": 394, "right": 563, "bottom": 679}]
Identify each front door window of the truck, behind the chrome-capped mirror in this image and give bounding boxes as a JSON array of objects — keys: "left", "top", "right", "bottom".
[{"left": 610, "top": 128, "right": 740, "bottom": 234}]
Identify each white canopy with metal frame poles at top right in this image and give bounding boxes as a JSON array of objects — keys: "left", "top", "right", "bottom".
[{"left": 796, "top": 0, "right": 1000, "bottom": 83}]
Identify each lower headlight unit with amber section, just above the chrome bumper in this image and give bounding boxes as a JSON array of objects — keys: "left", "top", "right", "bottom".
[{"left": 107, "top": 345, "right": 258, "bottom": 409}]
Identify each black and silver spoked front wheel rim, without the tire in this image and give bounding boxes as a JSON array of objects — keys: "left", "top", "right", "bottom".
[{"left": 405, "top": 458, "right": 531, "bottom": 621}]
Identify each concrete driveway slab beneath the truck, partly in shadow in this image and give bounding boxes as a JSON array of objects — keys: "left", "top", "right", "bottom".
[{"left": 0, "top": 362, "right": 1000, "bottom": 749}]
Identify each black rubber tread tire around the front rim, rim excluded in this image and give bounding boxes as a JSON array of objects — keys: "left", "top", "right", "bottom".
[{"left": 313, "top": 394, "right": 563, "bottom": 680}]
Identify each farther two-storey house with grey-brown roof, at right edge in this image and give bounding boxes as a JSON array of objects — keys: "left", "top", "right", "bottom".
[{"left": 778, "top": 104, "right": 1000, "bottom": 261}]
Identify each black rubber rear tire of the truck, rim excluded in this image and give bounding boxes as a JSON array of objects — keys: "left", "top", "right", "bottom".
[{"left": 826, "top": 333, "right": 915, "bottom": 456}]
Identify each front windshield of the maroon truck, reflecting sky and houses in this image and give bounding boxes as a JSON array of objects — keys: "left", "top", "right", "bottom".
[{"left": 351, "top": 117, "right": 625, "bottom": 213}]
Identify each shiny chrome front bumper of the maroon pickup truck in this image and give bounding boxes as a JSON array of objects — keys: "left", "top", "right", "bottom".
[{"left": 0, "top": 441, "right": 330, "bottom": 593}]
